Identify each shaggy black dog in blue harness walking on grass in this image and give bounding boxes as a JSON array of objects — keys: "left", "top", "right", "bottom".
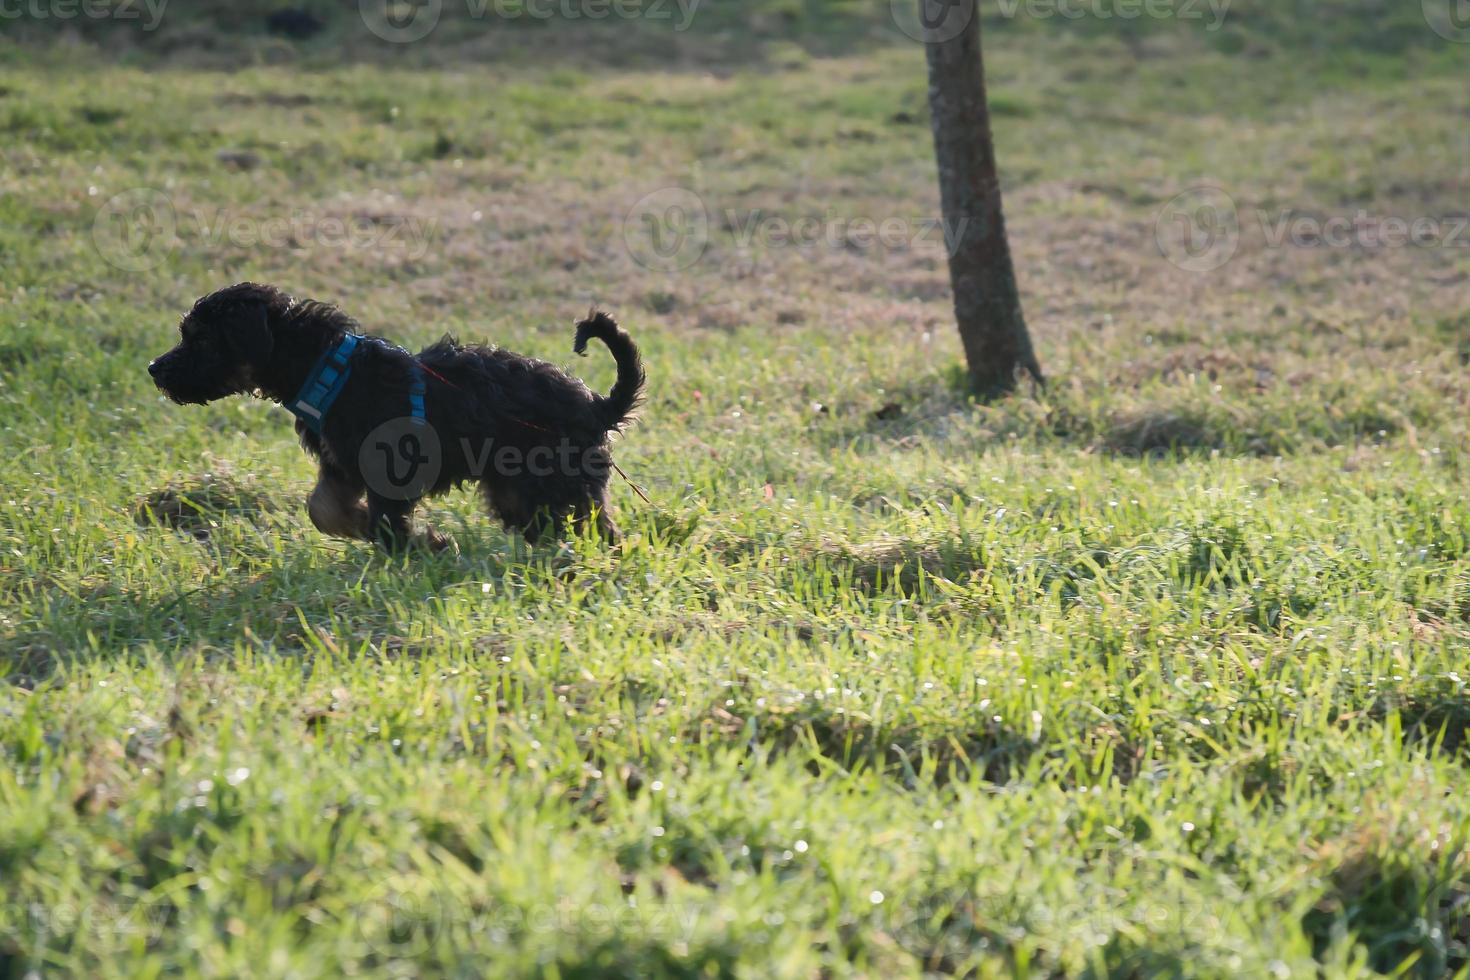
[{"left": 148, "top": 282, "right": 644, "bottom": 550}]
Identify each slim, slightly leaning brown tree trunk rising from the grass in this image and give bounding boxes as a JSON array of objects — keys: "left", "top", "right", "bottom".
[{"left": 916, "top": 0, "right": 1044, "bottom": 398}]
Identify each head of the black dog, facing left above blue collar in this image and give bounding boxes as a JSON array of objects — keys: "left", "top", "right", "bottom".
[{"left": 148, "top": 282, "right": 291, "bottom": 406}]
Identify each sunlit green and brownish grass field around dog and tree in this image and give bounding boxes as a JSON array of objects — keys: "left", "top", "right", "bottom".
[{"left": 0, "top": 3, "right": 1470, "bottom": 977}]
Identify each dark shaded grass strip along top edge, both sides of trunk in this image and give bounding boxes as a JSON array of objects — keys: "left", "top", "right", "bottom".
[{"left": 6, "top": 0, "right": 1452, "bottom": 72}]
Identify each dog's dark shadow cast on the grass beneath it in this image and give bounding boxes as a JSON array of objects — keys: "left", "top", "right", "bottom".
[{"left": 4, "top": 499, "right": 540, "bottom": 688}]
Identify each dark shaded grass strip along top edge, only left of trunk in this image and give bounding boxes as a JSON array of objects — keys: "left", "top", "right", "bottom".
[{"left": 7, "top": 0, "right": 899, "bottom": 75}]
